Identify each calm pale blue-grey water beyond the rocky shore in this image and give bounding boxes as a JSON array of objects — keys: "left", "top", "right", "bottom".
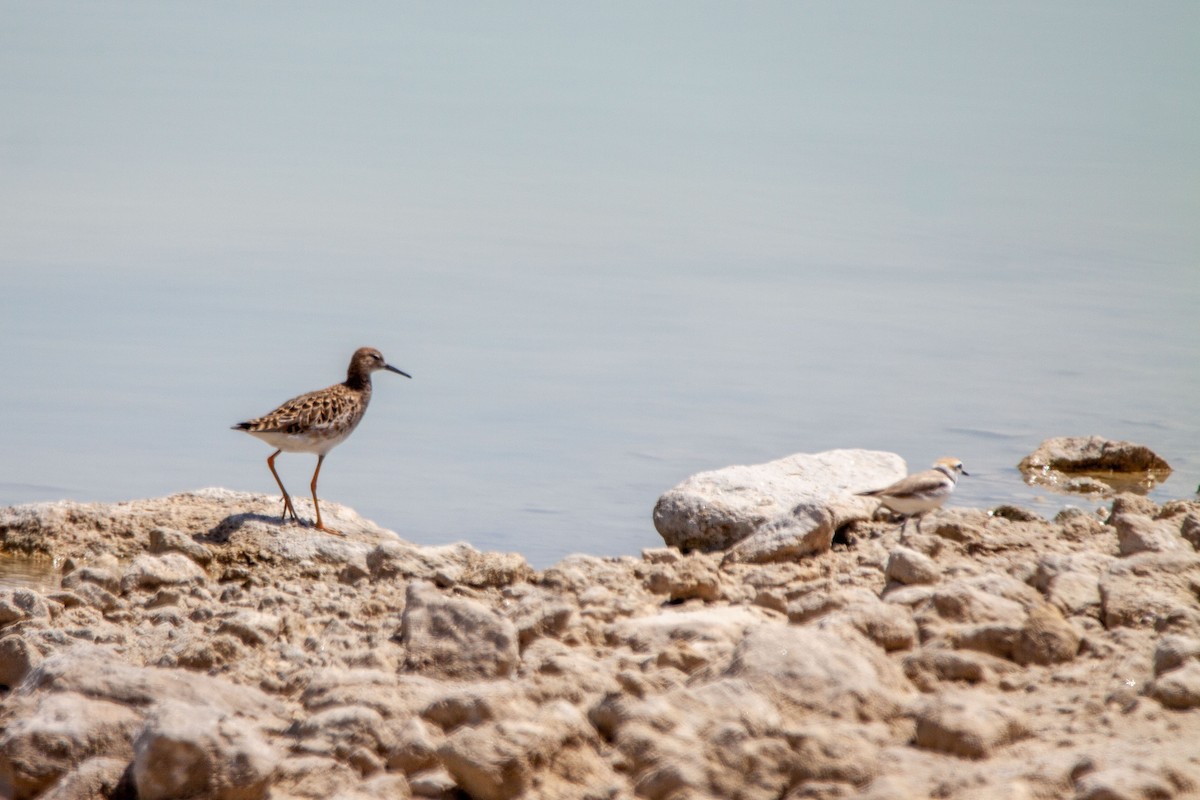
[{"left": 0, "top": 2, "right": 1200, "bottom": 566}]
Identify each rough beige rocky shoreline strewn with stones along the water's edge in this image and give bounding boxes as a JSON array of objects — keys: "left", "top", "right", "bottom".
[{"left": 0, "top": 451, "right": 1200, "bottom": 800}]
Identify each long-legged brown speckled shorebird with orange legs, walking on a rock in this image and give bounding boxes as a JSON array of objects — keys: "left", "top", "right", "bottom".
[{"left": 233, "top": 348, "right": 412, "bottom": 534}]
